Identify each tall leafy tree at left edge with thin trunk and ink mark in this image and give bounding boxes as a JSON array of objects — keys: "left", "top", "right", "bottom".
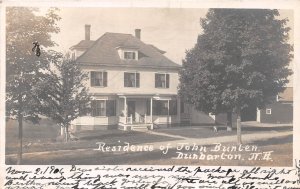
[{"left": 6, "top": 7, "right": 60, "bottom": 164}]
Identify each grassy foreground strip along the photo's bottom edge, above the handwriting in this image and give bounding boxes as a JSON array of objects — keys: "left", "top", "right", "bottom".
[{"left": 8, "top": 135, "right": 293, "bottom": 166}]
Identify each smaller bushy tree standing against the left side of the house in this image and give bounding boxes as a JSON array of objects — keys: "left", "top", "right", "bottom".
[{"left": 38, "top": 55, "right": 90, "bottom": 142}]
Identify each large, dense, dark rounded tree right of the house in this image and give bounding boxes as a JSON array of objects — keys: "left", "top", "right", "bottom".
[{"left": 180, "top": 9, "right": 292, "bottom": 143}]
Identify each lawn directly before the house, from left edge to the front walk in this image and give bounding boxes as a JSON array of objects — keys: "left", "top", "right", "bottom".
[{"left": 5, "top": 119, "right": 177, "bottom": 155}]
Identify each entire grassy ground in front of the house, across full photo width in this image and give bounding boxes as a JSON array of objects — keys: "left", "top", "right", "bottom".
[{"left": 6, "top": 119, "right": 293, "bottom": 166}]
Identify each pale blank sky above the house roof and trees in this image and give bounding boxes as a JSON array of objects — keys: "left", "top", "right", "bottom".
[{"left": 48, "top": 7, "right": 294, "bottom": 86}]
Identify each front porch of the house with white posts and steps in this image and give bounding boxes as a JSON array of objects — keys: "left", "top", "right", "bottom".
[{"left": 118, "top": 95, "right": 178, "bottom": 131}]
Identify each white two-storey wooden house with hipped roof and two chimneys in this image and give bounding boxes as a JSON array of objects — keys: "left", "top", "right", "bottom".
[{"left": 70, "top": 25, "right": 213, "bottom": 130}]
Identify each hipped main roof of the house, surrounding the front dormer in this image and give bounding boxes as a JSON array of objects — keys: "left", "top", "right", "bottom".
[{"left": 77, "top": 33, "right": 181, "bottom": 68}]
